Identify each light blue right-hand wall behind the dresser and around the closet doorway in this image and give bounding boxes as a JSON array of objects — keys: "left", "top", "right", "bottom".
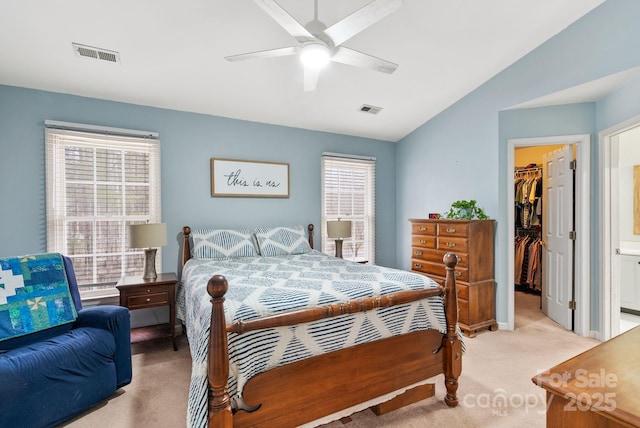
[{"left": 396, "top": 0, "right": 640, "bottom": 328}]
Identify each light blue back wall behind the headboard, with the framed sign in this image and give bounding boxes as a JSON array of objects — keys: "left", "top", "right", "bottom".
[{"left": 0, "top": 86, "right": 396, "bottom": 271}]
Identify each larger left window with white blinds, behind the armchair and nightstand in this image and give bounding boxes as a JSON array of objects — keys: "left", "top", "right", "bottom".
[{"left": 45, "top": 121, "right": 162, "bottom": 297}]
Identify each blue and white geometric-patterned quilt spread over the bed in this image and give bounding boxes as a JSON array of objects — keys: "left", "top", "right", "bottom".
[{"left": 178, "top": 250, "right": 446, "bottom": 427}]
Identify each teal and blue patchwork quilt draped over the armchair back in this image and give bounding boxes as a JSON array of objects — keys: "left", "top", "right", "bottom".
[{"left": 0, "top": 253, "right": 78, "bottom": 341}]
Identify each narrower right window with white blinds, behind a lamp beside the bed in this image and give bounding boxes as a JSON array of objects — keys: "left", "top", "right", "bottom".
[{"left": 322, "top": 153, "right": 376, "bottom": 263}]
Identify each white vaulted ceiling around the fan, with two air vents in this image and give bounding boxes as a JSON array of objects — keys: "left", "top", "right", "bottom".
[{"left": 0, "top": 0, "right": 603, "bottom": 141}]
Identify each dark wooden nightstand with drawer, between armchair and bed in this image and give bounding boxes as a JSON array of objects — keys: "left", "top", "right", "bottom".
[{"left": 116, "top": 272, "right": 178, "bottom": 351}]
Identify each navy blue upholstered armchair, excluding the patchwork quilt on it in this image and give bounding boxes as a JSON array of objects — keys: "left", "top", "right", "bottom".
[{"left": 0, "top": 257, "right": 131, "bottom": 427}]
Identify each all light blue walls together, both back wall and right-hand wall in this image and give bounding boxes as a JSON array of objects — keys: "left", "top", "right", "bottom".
[{"left": 0, "top": 0, "right": 640, "bottom": 336}]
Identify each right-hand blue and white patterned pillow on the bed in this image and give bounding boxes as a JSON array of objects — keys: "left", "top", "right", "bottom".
[{"left": 254, "top": 225, "right": 311, "bottom": 256}]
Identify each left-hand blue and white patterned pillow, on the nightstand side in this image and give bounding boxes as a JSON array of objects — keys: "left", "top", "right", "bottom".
[{"left": 191, "top": 229, "right": 258, "bottom": 260}]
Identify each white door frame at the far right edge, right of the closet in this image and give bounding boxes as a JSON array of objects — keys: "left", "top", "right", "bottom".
[{"left": 598, "top": 116, "right": 640, "bottom": 340}]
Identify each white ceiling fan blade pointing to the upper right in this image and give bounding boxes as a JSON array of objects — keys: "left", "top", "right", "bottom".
[{"left": 324, "top": 0, "right": 404, "bottom": 46}]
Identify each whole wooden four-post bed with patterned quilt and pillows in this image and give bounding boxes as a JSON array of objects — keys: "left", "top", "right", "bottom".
[{"left": 177, "top": 225, "right": 463, "bottom": 428}]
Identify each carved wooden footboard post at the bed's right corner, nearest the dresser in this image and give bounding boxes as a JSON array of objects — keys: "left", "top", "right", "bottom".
[{"left": 442, "top": 253, "right": 462, "bottom": 407}]
